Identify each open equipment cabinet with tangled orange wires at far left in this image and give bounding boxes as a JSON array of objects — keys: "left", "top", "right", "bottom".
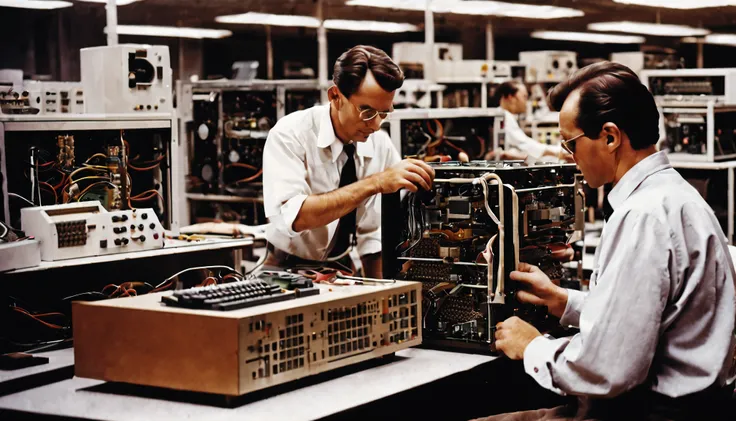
[{"left": 0, "top": 114, "right": 178, "bottom": 229}]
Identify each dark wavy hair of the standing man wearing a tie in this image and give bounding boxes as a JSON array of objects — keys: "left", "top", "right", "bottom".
[{"left": 332, "top": 45, "right": 404, "bottom": 98}]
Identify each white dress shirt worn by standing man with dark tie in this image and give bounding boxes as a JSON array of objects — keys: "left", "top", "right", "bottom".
[{"left": 263, "top": 104, "right": 400, "bottom": 260}]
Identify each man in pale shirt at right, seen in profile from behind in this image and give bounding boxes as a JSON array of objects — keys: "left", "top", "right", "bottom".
[{"left": 478, "top": 62, "right": 736, "bottom": 420}]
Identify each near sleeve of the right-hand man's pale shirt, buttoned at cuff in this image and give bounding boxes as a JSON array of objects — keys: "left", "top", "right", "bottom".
[{"left": 524, "top": 212, "right": 673, "bottom": 397}]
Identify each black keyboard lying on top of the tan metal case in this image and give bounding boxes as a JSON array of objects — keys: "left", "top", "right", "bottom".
[{"left": 161, "top": 279, "right": 306, "bottom": 311}]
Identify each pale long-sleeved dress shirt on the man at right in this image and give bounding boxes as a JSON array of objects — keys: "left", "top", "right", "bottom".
[{"left": 524, "top": 152, "right": 736, "bottom": 398}]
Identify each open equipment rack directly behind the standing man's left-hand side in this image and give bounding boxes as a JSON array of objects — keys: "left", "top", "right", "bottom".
[{"left": 178, "top": 80, "right": 321, "bottom": 225}]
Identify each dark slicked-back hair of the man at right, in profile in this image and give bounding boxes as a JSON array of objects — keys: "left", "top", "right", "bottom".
[{"left": 549, "top": 61, "right": 659, "bottom": 150}]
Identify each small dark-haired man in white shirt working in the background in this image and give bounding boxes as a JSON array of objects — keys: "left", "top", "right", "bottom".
[{"left": 487, "top": 80, "right": 572, "bottom": 163}]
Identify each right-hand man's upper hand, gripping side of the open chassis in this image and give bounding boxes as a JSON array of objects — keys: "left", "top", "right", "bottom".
[{"left": 510, "top": 263, "right": 567, "bottom": 318}]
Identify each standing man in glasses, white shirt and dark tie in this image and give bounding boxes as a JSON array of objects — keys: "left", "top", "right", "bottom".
[{"left": 263, "top": 45, "right": 434, "bottom": 277}]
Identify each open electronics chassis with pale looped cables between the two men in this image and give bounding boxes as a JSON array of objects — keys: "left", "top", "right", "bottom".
[{"left": 381, "top": 161, "right": 584, "bottom": 353}]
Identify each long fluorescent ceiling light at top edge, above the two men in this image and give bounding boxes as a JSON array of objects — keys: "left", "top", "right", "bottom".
[{"left": 345, "top": 0, "right": 585, "bottom": 19}]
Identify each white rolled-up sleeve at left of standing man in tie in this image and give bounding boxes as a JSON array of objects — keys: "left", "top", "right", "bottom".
[{"left": 263, "top": 129, "right": 312, "bottom": 238}]
